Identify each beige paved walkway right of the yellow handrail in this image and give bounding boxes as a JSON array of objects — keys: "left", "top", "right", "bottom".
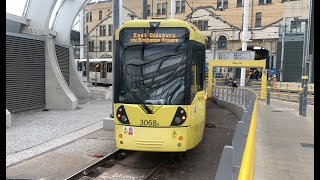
[{"left": 254, "top": 100, "right": 314, "bottom": 180}]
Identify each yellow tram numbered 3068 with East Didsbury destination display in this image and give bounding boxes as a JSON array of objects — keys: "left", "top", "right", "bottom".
[{"left": 113, "top": 20, "right": 206, "bottom": 152}]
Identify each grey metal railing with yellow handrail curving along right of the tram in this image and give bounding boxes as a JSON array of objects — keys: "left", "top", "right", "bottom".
[{"left": 212, "top": 87, "right": 258, "bottom": 180}]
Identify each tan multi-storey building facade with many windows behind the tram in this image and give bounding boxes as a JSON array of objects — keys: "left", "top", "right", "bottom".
[{"left": 84, "top": 0, "right": 309, "bottom": 80}]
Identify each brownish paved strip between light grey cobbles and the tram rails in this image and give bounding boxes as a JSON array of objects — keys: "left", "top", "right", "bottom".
[{"left": 6, "top": 127, "right": 117, "bottom": 179}]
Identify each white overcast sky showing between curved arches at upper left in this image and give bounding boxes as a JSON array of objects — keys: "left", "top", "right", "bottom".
[{"left": 6, "top": 0, "right": 85, "bottom": 31}]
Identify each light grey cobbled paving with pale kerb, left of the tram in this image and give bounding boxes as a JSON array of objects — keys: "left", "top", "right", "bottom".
[{"left": 6, "top": 87, "right": 112, "bottom": 166}]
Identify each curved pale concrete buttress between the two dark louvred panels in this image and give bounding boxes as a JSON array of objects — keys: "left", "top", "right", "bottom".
[{"left": 45, "top": 37, "right": 78, "bottom": 110}]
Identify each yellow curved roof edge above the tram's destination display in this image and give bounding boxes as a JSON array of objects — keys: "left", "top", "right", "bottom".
[{"left": 116, "top": 19, "right": 205, "bottom": 44}]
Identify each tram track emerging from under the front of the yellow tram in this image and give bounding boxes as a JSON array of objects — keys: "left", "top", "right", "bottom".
[{"left": 66, "top": 150, "right": 176, "bottom": 180}]
